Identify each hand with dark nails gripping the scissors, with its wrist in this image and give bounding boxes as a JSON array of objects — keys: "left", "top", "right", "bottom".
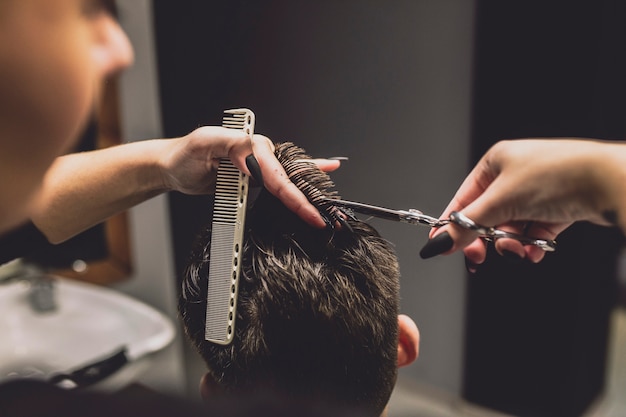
[{"left": 431, "top": 139, "right": 626, "bottom": 264}]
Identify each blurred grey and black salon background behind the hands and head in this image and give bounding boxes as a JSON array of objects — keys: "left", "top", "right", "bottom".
[{"left": 17, "top": 0, "right": 626, "bottom": 417}]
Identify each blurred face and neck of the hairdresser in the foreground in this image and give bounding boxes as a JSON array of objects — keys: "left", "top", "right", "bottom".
[{"left": 0, "top": 0, "right": 133, "bottom": 232}]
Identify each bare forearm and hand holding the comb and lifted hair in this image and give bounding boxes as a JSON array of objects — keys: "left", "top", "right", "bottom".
[{"left": 32, "top": 127, "right": 339, "bottom": 243}]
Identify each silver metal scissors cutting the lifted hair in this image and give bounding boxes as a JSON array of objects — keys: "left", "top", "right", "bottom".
[{"left": 324, "top": 198, "right": 556, "bottom": 252}]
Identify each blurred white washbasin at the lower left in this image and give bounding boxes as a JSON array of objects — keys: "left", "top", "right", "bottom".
[{"left": 0, "top": 272, "right": 175, "bottom": 388}]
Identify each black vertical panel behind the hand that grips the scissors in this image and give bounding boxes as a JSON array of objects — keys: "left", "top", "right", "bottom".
[{"left": 464, "top": 0, "right": 626, "bottom": 417}]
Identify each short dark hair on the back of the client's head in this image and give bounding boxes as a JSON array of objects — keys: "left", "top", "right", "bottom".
[{"left": 179, "top": 144, "right": 400, "bottom": 415}]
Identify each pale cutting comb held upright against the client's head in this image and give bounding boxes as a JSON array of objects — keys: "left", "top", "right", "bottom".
[{"left": 204, "top": 109, "right": 254, "bottom": 345}]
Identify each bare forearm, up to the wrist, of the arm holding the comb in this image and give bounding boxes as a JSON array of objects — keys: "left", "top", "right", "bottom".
[{"left": 32, "top": 140, "right": 170, "bottom": 243}]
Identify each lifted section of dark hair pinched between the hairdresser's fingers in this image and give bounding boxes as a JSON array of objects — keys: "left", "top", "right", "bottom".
[{"left": 276, "top": 142, "right": 350, "bottom": 229}]
